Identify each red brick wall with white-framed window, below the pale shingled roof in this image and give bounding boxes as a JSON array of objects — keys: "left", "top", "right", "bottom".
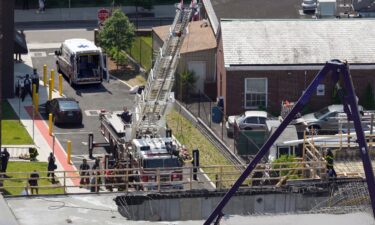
[{"left": 225, "top": 68, "right": 375, "bottom": 115}]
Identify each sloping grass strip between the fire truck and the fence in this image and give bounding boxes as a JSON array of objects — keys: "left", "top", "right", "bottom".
[{"left": 167, "top": 110, "right": 239, "bottom": 187}]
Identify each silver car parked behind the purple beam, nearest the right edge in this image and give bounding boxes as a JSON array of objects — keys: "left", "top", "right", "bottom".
[{"left": 296, "top": 105, "right": 363, "bottom": 132}]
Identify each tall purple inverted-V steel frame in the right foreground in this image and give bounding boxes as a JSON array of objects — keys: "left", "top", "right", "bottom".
[{"left": 204, "top": 60, "right": 375, "bottom": 225}]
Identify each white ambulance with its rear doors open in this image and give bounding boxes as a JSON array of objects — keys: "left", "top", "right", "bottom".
[{"left": 55, "top": 39, "right": 109, "bottom": 85}]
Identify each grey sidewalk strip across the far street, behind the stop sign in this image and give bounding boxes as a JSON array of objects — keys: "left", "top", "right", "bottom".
[{"left": 14, "top": 5, "right": 175, "bottom": 23}]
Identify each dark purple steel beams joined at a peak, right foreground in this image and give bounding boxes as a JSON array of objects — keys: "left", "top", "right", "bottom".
[{"left": 204, "top": 60, "right": 375, "bottom": 225}]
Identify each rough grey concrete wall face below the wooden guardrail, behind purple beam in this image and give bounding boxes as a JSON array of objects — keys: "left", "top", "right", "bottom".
[{"left": 119, "top": 193, "right": 327, "bottom": 221}]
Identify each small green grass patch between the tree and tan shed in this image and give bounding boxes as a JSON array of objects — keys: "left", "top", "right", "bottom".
[{"left": 129, "top": 36, "right": 152, "bottom": 70}]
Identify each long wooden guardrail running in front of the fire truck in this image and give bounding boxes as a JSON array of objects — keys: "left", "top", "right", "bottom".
[{"left": 0, "top": 161, "right": 332, "bottom": 196}]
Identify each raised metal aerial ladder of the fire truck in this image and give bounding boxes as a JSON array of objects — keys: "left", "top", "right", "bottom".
[{"left": 136, "top": 3, "right": 193, "bottom": 137}]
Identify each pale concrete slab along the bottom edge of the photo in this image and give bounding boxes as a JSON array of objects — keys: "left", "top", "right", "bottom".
[{"left": 0, "top": 193, "right": 375, "bottom": 225}]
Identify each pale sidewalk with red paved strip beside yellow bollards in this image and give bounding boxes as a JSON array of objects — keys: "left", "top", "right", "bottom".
[{"left": 8, "top": 55, "right": 88, "bottom": 193}]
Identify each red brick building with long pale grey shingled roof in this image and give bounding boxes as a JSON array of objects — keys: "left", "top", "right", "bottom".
[{"left": 217, "top": 19, "right": 375, "bottom": 115}]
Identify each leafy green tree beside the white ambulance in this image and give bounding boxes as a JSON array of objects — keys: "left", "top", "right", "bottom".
[{"left": 98, "top": 9, "right": 135, "bottom": 67}]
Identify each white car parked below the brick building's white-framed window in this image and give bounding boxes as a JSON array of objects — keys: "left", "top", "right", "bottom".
[{"left": 225, "top": 111, "right": 267, "bottom": 137}]
